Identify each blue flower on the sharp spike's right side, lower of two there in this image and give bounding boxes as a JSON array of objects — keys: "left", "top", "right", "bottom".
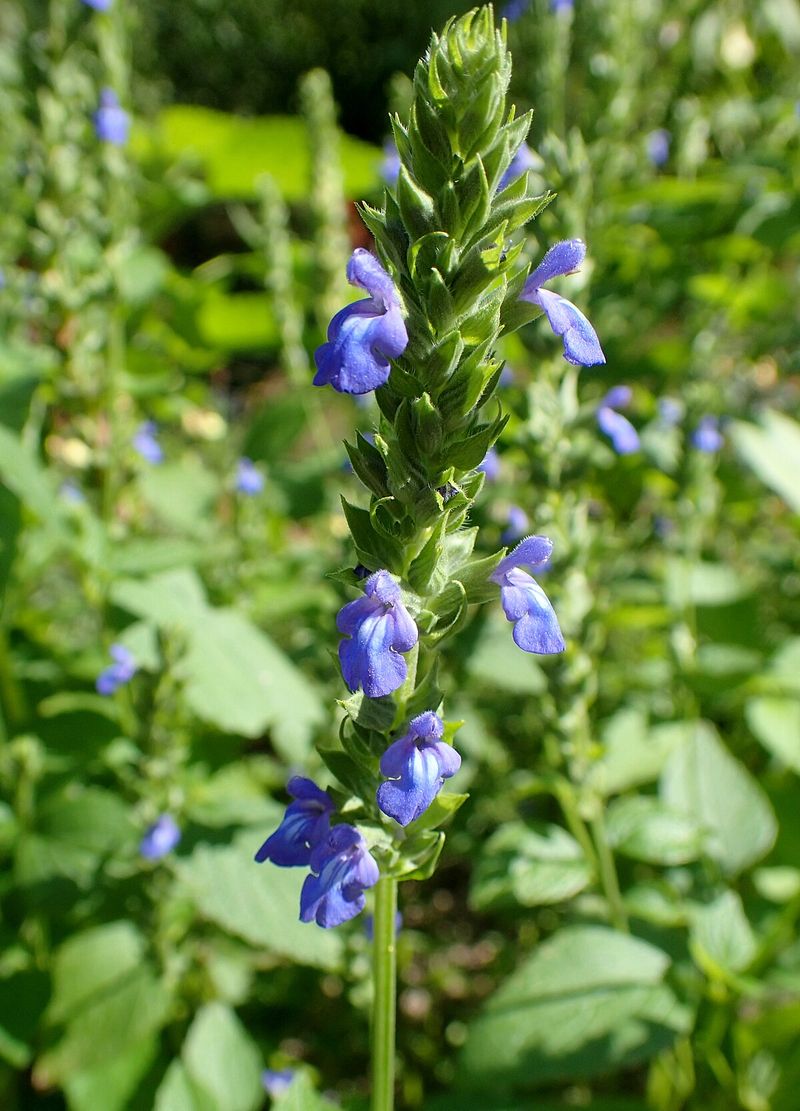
[{"left": 489, "top": 537, "right": 566, "bottom": 655}]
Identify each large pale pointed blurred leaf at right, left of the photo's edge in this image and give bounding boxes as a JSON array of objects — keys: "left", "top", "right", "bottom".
[{"left": 660, "top": 721, "right": 777, "bottom": 875}]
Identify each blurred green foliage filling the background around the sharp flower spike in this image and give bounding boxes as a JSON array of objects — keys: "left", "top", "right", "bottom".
[{"left": 0, "top": 0, "right": 800, "bottom": 1111}]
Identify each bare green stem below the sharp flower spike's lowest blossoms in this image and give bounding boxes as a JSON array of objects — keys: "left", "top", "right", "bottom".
[{"left": 372, "top": 877, "right": 397, "bottom": 1111}]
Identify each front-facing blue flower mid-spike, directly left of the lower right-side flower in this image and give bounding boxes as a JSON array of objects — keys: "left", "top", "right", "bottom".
[{"left": 337, "top": 571, "right": 419, "bottom": 698}]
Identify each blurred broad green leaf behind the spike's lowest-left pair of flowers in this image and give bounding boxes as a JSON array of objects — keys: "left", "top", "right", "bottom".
[{"left": 178, "top": 828, "right": 342, "bottom": 969}]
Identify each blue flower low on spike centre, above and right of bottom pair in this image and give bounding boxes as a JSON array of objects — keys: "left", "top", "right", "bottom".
[{"left": 377, "top": 710, "right": 461, "bottom": 825}]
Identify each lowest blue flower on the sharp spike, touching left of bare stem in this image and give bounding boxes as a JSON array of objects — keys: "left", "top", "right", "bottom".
[{"left": 300, "top": 824, "right": 380, "bottom": 929}]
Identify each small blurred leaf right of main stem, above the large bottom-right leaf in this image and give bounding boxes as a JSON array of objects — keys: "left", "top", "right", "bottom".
[{"left": 470, "top": 822, "right": 592, "bottom": 910}]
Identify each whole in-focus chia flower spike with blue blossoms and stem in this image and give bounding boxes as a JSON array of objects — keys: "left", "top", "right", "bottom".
[{"left": 257, "top": 7, "right": 604, "bottom": 1111}]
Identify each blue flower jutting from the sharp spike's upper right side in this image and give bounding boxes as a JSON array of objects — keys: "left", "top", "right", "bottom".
[{"left": 520, "top": 239, "right": 606, "bottom": 367}]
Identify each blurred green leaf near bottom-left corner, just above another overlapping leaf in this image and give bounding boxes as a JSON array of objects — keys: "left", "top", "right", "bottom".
[{"left": 47, "top": 921, "right": 146, "bottom": 1023}]
